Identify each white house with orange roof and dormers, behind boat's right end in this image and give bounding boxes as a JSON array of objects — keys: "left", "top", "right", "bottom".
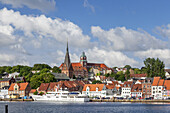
[{"left": 82, "top": 84, "right": 106, "bottom": 97}]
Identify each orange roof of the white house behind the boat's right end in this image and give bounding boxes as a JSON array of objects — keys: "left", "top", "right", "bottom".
[{"left": 82, "top": 84, "right": 105, "bottom": 91}]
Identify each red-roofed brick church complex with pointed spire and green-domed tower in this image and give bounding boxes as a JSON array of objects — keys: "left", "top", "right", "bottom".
[{"left": 59, "top": 42, "right": 110, "bottom": 78}]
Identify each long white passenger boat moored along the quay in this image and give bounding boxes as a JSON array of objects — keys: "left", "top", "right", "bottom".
[{"left": 32, "top": 91, "right": 89, "bottom": 102}]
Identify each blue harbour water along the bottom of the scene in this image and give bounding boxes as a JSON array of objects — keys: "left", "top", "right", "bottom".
[{"left": 0, "top": 101, "right": 170, "bottom": 113}]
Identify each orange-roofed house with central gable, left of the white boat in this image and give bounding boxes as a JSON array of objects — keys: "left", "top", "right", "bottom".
[{"left": 8, "top": 82, "right": 31, "bottom": 98}]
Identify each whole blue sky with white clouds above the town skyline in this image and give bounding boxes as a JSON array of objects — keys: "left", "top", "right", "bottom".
[{"left": 0, "top": 0, "right": 170, "bottom": 68}]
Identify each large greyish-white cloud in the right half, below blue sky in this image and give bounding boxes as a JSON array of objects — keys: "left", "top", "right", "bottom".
[{"left": 91, "top": 26, "right": 167, "bottom": 51}]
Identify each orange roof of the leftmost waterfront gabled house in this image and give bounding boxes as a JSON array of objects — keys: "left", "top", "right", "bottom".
[{"left": 8, "top": 82, "right": 29, "bottom": 91}]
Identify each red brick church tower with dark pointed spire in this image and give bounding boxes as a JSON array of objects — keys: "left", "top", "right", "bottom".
[{"left": 61, "top": 41, "right": 73, "bottom": 78}]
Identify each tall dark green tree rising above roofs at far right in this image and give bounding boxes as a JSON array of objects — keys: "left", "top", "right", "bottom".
[{"left": 144, "top": 58, "right": 165, "bottom": 78}]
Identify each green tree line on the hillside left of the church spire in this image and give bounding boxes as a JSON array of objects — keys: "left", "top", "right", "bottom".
[{"left": 0, "top": 64, "right": 61, "bottom": 89}]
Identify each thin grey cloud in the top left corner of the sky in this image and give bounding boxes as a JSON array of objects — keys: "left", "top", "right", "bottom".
[{"left": 0, "top": 0, "right": 56, "bottom": 12}]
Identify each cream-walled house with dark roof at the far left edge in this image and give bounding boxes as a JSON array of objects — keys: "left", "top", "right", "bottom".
[{"left": 0, "top": 77, "right": 15, "bottom": 89}]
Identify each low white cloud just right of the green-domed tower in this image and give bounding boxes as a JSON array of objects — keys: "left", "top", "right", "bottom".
[{"left": 86, "top": 47, "right": 139, "bottom": 67}]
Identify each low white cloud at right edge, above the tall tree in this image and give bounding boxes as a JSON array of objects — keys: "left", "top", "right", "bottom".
[{"left": 134, "top": 49, "right": 170, "bottom": 67}]
